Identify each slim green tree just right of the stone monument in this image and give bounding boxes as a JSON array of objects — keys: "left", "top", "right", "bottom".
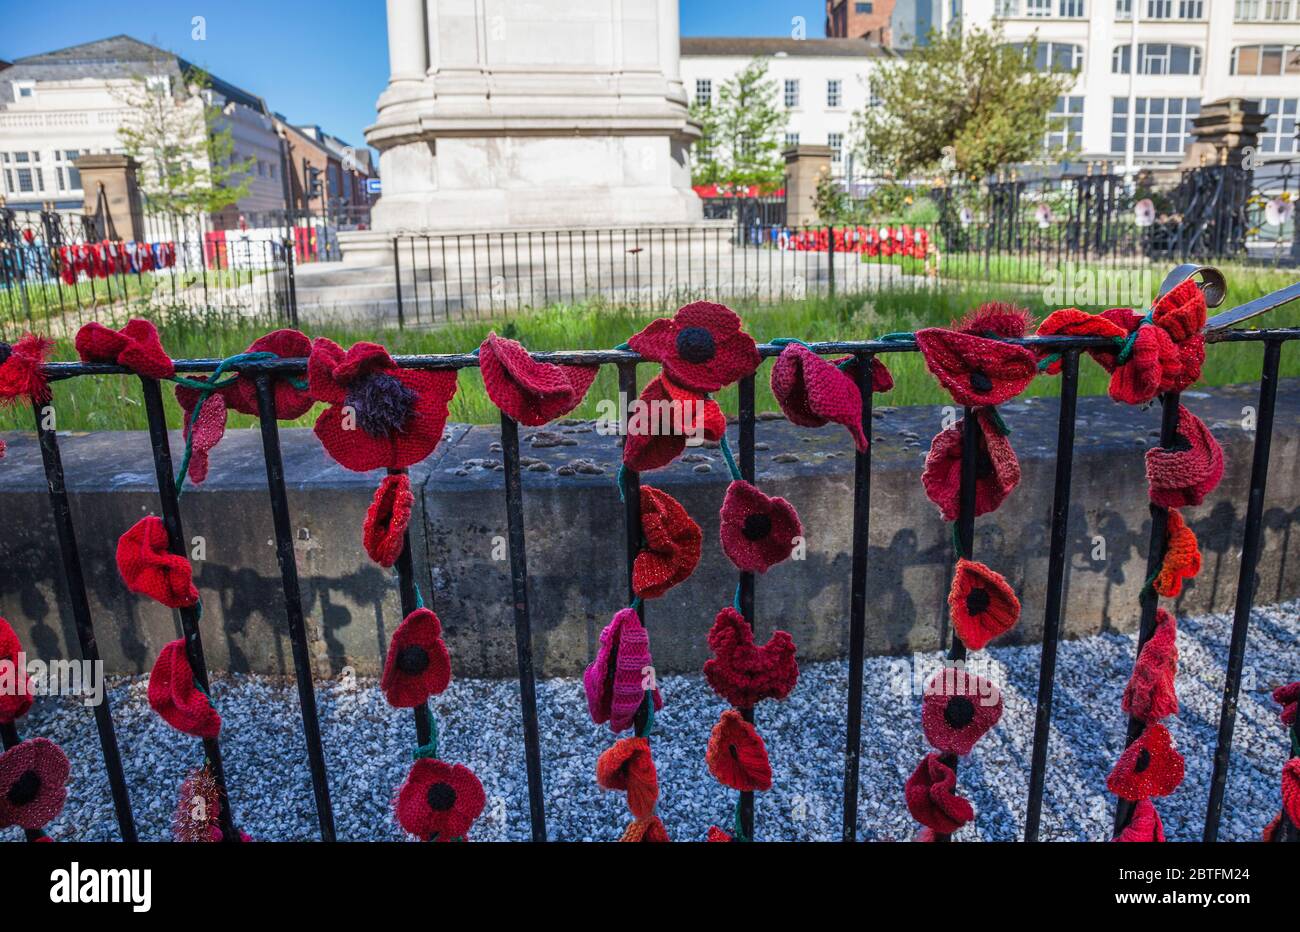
[{"left": 690, "top": 58, "right": 787, "bottom": 190}]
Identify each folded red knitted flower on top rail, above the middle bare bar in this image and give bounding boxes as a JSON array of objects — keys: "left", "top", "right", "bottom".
[{"left": 478, "top": 331, "right": 599, "bottom": 428}]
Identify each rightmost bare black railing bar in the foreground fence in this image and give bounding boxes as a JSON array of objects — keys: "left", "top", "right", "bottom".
[{"left": 1203, "top": 339, "right": 1282, "bottom": 841}]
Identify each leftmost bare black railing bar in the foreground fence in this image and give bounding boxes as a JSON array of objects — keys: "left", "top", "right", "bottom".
[{"left": 31, "top": 402, "right": 138, "bottom": 841}]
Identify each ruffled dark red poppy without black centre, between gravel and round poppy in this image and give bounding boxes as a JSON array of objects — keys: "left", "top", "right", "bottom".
[{"left": 705, "top": 606, "right": 800, "bottom": 708}]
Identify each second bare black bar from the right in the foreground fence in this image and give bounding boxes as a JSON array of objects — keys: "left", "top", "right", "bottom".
[{"left": 1024, "top": 350, "right": 1079, "bottom": 841}]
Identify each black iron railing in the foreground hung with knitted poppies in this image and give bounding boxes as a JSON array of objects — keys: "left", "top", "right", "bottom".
[{"left": 0, "top": 266, "right": 1300, "bottom": 842}]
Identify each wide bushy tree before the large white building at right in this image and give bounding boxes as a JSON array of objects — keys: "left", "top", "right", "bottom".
[{"left": 855, "top": 26, "right": 1074, "bottom": 179}]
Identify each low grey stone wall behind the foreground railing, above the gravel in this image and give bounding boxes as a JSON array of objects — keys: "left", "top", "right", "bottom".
[{"left": 0, "top": 380, "right": 1300, "bottom": 676}]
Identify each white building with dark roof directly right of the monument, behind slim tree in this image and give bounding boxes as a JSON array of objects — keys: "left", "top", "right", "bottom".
[{"left": 681, "top": 38, "right": 894, "bottom": 179}]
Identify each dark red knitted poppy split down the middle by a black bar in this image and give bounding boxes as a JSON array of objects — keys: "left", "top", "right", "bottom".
[{"left": 920, "top": 408, "right": 1021, "bottom": 521}]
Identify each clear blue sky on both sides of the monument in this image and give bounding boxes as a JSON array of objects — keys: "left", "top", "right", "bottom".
[{"left": 0, "top": 0, "right": 824, "bottom": 144}]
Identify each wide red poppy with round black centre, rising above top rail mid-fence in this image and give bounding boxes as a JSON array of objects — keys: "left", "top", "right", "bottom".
[{"left": 628, "top": 302, "right": 762, "bottom": 391}]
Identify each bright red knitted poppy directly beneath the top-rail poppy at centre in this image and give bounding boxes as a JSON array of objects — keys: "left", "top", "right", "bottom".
[{"left": 623, "top": 376, "right": 727, "bottom": 472}]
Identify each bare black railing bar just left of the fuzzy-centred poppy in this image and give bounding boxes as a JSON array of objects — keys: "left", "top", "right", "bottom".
[{"left": 256, "top": 374, "right": 334, "bottom": 841}]
